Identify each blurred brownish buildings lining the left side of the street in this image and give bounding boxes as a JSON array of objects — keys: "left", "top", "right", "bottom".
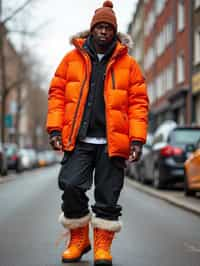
[{"left": 0, "top": 24, "right": 48, "bottom": 148}]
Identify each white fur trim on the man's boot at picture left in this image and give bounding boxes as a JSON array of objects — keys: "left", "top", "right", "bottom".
[{"left": 58, "top": 212, "right": 91, "bottom": 229}]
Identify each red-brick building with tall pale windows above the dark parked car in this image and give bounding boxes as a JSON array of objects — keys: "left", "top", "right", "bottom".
[{"left": 144, "top": 0, "right": 191, "bottom": 129}]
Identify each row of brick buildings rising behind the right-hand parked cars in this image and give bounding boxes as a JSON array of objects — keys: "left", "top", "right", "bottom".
[{"left": 128, "top": 0, "right": 200, "bottom": 130}]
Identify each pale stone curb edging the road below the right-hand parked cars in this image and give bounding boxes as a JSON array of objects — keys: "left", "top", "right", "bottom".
[{"left": 126, "top": 178, "right": 200, "bottom": 216}]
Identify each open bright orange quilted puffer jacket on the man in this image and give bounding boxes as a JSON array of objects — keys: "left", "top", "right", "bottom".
[{"left": 46, "top": 32, "right": 148, "bottom": 158}]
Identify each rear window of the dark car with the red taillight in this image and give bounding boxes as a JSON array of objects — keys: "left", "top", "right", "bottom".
[{"left": 173, "top": 128, "right": 200, "bottom": 144}]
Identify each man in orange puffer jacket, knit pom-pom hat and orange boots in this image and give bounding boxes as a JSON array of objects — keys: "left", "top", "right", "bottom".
[{"left": 47, "top": 1, "right": 148, "bottom": 265}]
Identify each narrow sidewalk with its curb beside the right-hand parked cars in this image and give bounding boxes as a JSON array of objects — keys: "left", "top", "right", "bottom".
[{"left": 126, "top": 178, "right": 200, "bottom": 216}]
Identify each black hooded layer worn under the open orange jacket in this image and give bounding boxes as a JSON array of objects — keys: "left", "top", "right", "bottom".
[{"left": 78, "top": 36, "right": 116, "bottom": 140}]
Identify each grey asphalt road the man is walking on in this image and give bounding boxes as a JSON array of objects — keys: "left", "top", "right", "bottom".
[{"left": 0, "top": 166, "right": 200, "bottom": 266}]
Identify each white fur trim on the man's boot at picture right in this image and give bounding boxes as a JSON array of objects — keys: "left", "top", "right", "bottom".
[{"left": 92, "top": 217, "right": 122, "bottom": 232}]
